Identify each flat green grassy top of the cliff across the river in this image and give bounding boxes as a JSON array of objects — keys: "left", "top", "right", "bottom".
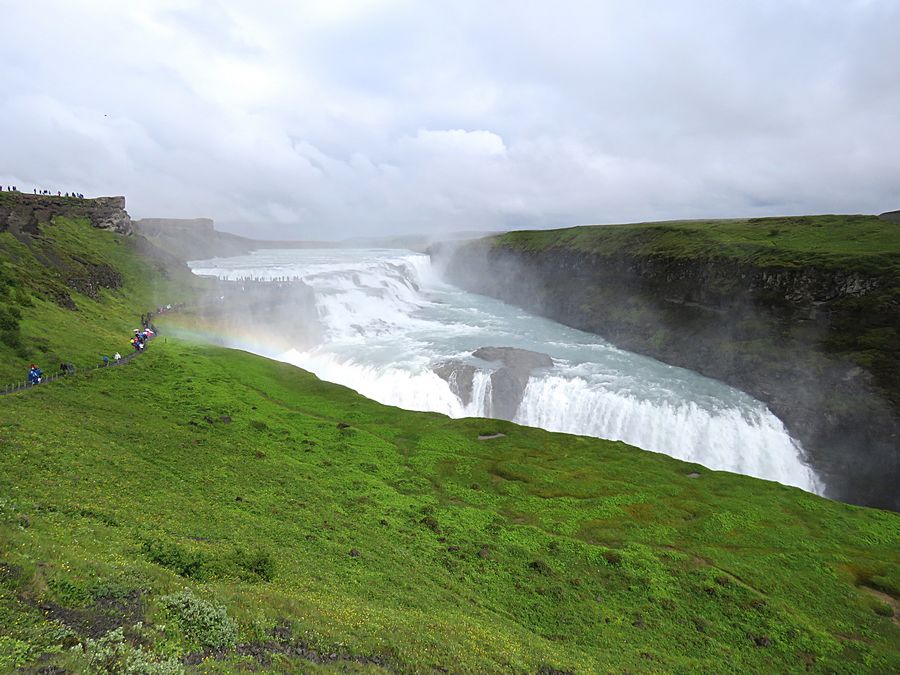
[{"left": 494, "top": 215, "right": 900, "bottom": 274}]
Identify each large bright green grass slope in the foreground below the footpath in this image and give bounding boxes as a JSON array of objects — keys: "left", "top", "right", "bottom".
[{"left": 0, "top": 339, "right": 900, "bottom": 673}]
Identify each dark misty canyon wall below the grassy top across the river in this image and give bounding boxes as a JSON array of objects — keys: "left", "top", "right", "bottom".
[{"left": 432, "top": 224, "right": 900, "bottom": 510}]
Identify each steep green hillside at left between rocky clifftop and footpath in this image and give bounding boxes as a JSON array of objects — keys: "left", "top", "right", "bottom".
[{"left": 0, "top": 218, "right": 200, "bottom": 386}]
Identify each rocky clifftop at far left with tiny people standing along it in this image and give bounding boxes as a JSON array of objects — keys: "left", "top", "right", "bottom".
[{"left": 0, "top": 192, "right": 132, "bottom": 236}]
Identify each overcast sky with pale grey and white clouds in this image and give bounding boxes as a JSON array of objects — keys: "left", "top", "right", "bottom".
[{"left": 0, "top": 0, "right": 900, "bottom": 239}]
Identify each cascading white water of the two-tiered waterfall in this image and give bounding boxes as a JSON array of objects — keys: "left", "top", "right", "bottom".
[{"left": 191, "top": 249, "right": 820, "bottom": 492}]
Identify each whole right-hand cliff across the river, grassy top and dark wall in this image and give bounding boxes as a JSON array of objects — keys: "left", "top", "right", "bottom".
[{"left": 433, "top": 216, "right": 900, "bottom": 510}]
